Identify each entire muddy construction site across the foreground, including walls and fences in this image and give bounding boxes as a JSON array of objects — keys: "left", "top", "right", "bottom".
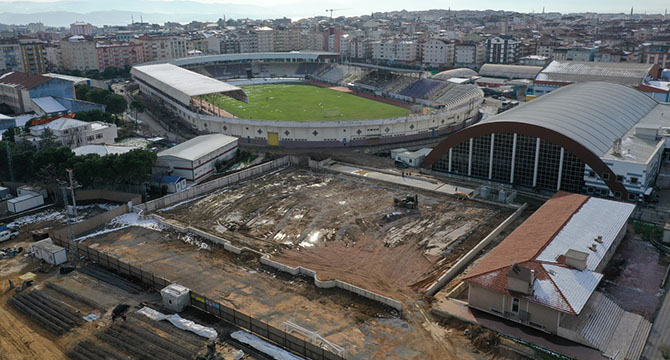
[{"left": 0, "top": 156, "right": 665, "bottom": 360}]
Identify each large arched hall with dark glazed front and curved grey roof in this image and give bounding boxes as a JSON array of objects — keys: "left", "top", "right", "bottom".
[{"left": 423, "top": 82, "right": 670, "bottom": 201}]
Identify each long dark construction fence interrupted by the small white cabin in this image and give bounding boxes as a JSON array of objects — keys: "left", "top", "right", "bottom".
[{"left": 48, "top": 236, "right": 345, "bottom": 360}]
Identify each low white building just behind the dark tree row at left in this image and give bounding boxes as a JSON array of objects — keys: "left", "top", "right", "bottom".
[{"left": 27, "top": 118, "right": 118, "bottom": 149}]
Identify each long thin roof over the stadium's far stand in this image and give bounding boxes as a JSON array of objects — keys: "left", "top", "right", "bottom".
[{"left": 170, "top": 51, "right": 340, "bottom": 66}]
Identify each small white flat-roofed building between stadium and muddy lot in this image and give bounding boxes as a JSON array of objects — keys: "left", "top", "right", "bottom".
[{"left": 152, "top": 134, "right": 237, "bottom": 182}]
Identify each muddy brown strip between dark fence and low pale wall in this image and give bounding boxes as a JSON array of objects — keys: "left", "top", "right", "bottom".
[{"left": 84, "top": 227, "right": 494, "bottom": 359}]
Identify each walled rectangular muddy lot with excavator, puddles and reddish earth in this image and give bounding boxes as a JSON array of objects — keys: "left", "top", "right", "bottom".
[{"left": 159, "top": 169, "right": 511, "bottom": 296}]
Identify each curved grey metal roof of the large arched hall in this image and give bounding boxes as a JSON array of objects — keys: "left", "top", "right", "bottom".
[{"left": 484, "top": 82, "right": 658, "bottom": 156}]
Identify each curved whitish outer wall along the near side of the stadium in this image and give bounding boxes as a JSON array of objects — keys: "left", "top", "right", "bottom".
[{"left": 136, "top": 79, "right": 484, "bottom": 148}]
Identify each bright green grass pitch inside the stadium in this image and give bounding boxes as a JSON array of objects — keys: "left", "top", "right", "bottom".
[{"left": 203, "top": 83, "right": 409, "bottom": 121}]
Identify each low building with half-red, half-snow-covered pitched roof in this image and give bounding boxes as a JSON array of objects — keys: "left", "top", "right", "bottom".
[{"left": 464, "top": 192, "right": 648, "bottom": 354}]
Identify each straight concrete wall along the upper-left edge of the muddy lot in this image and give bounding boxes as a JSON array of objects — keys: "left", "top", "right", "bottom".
[{"left": 136, "top": 156, "right": 299, "bottom": 212}]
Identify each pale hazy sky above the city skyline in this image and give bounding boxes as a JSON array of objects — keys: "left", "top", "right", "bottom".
[{"left": 0, "top": 0, "right": 670, "bottom": 25}]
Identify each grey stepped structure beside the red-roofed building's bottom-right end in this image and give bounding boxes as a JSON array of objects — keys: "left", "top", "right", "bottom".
[{"left": 580, "top": 292, "right": 624, "bottom": 350}]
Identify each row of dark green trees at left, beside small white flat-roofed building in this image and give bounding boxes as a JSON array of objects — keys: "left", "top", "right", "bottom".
[{"left": 0, "top": 141, "right": 156, "bottom": 188}]
